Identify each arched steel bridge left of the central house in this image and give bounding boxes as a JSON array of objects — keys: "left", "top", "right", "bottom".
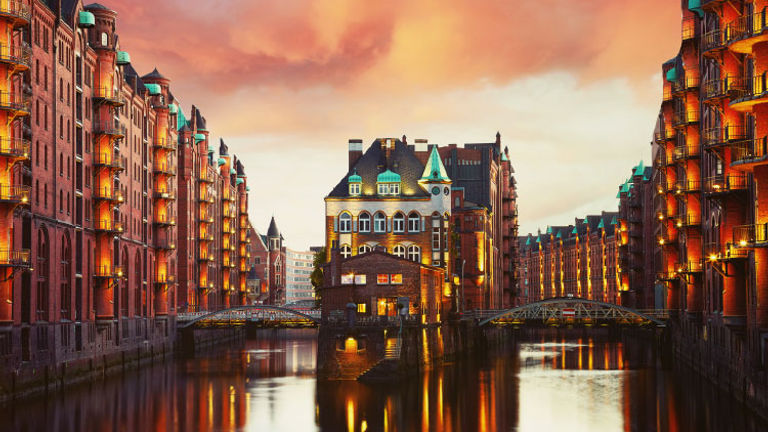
[{"left": 178, "top": 305, "right": 319, "bottom": 328}]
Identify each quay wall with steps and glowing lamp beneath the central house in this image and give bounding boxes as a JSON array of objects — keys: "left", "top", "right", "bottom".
[{"left": 317, "top": 321, "right": 481, "bottom": 381}]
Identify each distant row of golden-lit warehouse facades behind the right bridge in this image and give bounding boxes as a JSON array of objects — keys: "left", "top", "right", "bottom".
[{"left": 518, "top": 212, "right": 621, "bottom": 304}]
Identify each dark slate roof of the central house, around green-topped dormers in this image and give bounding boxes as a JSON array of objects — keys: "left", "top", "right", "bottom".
[{"left": 328, "top": 139, "right": 429, "bottom": 198}]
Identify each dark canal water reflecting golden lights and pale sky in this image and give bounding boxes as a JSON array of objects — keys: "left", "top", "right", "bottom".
[{"left": 0, "top": 330, "right": 768, "bottom": 432}]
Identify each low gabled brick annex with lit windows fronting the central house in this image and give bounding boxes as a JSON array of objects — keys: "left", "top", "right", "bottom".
[{"left": 321, "top": 247, "right": 450, "bottom": 323}]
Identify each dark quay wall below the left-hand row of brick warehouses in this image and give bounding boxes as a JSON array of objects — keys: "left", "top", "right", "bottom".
[{"left": 0, "top": 316, "right": 176, "bottom": 403}]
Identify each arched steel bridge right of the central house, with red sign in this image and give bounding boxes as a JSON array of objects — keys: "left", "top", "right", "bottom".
[{"left": 479, "top": 297, "right": 665, "bottom": 327}]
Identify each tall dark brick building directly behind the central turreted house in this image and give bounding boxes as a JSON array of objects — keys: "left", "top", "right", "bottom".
[{"left": 412, "top": 133, "right": 518, "bottom": 310}]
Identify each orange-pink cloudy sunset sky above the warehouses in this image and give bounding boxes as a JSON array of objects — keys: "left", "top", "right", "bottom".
[{"left": 101, "top": 0, "right": 681, "bottom": 249}]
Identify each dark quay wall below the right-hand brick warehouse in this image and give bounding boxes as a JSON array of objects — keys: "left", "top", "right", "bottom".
[{"left": 667, "top": 319, "right": 768, "bottom": 419}]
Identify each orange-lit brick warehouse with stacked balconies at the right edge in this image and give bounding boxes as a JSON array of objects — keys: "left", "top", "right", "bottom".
[{"left": 653, "top": 0, "right": 768, "bottom": 382}]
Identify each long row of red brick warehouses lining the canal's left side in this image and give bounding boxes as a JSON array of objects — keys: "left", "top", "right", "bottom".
[{"left": 0, "top": 0, "right": 252, "bottom": 370}]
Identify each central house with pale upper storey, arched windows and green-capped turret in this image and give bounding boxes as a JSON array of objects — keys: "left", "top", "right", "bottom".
[{"left": 325, "top": 138, "right": 453, "bottom": 314}]
